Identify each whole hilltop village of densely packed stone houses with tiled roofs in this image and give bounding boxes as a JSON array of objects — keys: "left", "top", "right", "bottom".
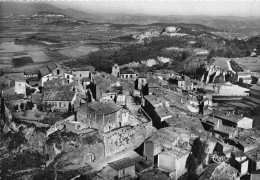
[{"left": 0, "top": 57, "right": 260, "bottom": 180}]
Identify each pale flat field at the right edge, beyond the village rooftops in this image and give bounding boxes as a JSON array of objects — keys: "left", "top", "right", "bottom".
[{"left": 234, "top": 56, "right": 260, "bottom": 72}]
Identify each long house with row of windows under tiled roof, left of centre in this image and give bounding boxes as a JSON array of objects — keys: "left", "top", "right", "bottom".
[{"left": 42, "top": 91, "right": 76, "bottom": 111}]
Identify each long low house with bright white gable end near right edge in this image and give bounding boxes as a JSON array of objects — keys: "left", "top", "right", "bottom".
[{"left": 211, "top": 111, "right": 253, "bottom": 129}]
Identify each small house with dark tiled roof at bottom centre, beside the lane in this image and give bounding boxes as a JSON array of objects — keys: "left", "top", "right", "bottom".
[{"left": 108, "top": 158, "right": 136, "bottom": 180}]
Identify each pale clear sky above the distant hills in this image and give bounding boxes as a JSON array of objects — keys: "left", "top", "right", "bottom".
[{"left": 47, "top": 0, "right": 260, "bottom": 17}]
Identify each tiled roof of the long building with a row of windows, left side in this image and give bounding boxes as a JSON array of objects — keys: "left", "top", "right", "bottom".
[{"left": 43, "top": 91, "right": 75, "bottom": 101}]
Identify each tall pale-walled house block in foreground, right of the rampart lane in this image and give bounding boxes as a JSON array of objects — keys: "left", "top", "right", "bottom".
[{"left": 143, "top": 126, "right": 191, "bottom": 179}]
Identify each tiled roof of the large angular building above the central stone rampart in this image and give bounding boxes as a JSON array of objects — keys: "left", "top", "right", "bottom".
[{"left": 78, "top": 100, "right": 121, "bottom": 114}]
